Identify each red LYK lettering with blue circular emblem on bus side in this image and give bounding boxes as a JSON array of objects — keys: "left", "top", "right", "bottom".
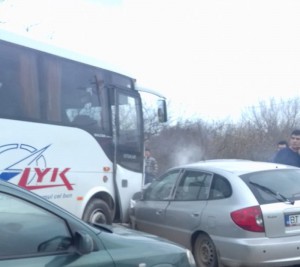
[{"left": 0, "top": 144, "right": 73, "bottom": 190}]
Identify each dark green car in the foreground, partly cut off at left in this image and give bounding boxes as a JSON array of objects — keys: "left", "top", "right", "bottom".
[{"left": 0, "top": 181, "right": 195, "bottom": 267}]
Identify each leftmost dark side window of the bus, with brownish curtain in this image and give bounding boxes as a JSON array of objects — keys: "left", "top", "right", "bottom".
[{"left": 0, "top": 45, "right": 41, "bottom": 120}]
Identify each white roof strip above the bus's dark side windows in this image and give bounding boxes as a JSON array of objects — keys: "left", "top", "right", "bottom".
[{"left": 0, "top": 29, "right": 135, "bottom": 80}]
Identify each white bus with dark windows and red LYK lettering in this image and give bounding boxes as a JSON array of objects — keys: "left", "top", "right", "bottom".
[{"left": 0, "top": 30, "right": 166, "bottom": 224}]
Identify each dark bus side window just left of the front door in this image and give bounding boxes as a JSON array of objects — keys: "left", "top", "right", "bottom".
[{"left": 58, "top": 62, "right": 104, "bottom": 135}]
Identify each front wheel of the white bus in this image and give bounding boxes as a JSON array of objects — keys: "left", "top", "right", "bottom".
[{"left": 82, "top": 198, "right": 112, "bottom": 224}]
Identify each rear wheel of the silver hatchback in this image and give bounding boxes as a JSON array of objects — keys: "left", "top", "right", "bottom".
[{"left": 194, "top": 234, "right": 218, "bottom": 267}]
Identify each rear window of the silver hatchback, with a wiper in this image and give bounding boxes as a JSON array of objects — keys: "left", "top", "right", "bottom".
[{"left": 241, "top": 169, "right": 300, "bottom": 204}]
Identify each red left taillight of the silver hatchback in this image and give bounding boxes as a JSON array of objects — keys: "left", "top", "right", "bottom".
[{"left": 230, "top": 206, "right": 265, "bottom": 232}]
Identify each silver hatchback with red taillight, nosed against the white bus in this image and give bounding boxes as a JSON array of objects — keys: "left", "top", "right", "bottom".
[{"left": 131, "top": 160, "right": 300, "bottom": 267}]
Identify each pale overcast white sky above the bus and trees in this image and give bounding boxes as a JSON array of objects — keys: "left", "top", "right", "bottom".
[{"left": 0, "top": 0, "right": 300, "bottom": 120}]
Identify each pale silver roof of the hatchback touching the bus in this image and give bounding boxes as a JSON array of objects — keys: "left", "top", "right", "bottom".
[{"left": 173, "top": 159, "right": 298, "bottom": 175}]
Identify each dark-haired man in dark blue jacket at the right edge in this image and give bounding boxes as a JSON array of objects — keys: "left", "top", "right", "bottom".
[{"left": 273, "top": 130, "right": 300, "bottom": 167}]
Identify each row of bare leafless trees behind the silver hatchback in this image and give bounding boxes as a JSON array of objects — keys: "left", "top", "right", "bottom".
[{"left": 149, "top": 97, "right": 300, "bottom": 175}]
